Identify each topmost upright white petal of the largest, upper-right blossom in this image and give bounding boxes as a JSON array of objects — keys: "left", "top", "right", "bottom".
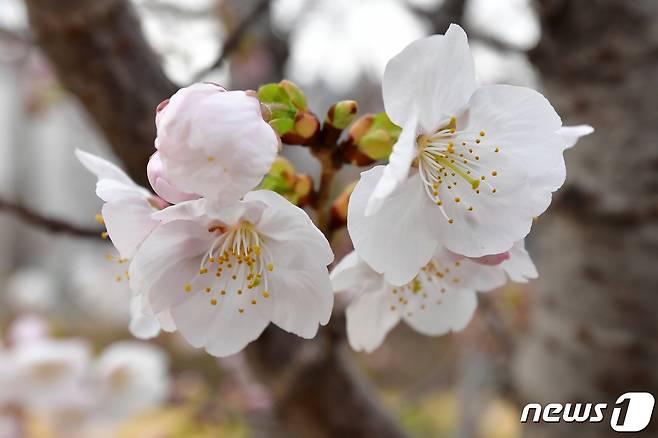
[{"left": 382, "top": 24, "right": 476, "bottom": 131}]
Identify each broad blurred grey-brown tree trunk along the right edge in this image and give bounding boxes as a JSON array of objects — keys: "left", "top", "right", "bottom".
[{"left": 517, "top": 0, "right": 658, "bottom": 438}]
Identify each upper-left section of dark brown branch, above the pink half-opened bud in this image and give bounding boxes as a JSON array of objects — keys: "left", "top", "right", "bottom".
[{"left": 26, "top": 0, "right": 176, "bottom": 185}]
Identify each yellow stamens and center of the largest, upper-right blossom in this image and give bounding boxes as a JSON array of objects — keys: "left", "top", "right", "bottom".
[{"left": 416, "top": 117, "right": 500, "bottom": 223}]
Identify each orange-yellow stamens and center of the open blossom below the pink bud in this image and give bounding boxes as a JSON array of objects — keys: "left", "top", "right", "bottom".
[{"left": 183, "top": 221, "right": 274, "bottom": 314}]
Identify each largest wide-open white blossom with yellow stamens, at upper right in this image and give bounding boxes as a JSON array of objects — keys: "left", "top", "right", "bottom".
[{"left": 348, "top": 25, "right": 588, "bottom": 285}]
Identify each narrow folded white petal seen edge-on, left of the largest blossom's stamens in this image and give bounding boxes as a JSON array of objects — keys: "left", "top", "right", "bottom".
[{"left": 366, "top": 116, "right": 418, "bottom": 216}]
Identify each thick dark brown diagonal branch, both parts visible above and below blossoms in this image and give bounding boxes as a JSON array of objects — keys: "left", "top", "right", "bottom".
[{"left": 26, "top": 0, "right": 403, "bottom": 438}]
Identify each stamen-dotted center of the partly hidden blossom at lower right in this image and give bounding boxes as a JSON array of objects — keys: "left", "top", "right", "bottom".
[{"left": 389, "top": 260, "right": 462, "bottom": 317}]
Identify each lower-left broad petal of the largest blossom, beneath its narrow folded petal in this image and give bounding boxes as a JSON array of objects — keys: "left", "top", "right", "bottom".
[{"left": 347, "top": 166, "right": 439, "bottom": 285}]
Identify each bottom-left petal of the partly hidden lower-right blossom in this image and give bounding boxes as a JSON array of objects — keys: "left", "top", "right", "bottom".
[{"left": 345, "top": 288, "right": 400, "bottom": 353}]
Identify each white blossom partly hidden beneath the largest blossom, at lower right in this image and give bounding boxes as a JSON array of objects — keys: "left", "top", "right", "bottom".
[{"left": 331, "top": 241, "right": 537, "bottom": 352}]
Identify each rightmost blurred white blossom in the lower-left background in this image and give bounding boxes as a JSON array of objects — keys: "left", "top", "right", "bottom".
[{"left": 91, "top": 341, "right": 170, "bottom": 421}]
